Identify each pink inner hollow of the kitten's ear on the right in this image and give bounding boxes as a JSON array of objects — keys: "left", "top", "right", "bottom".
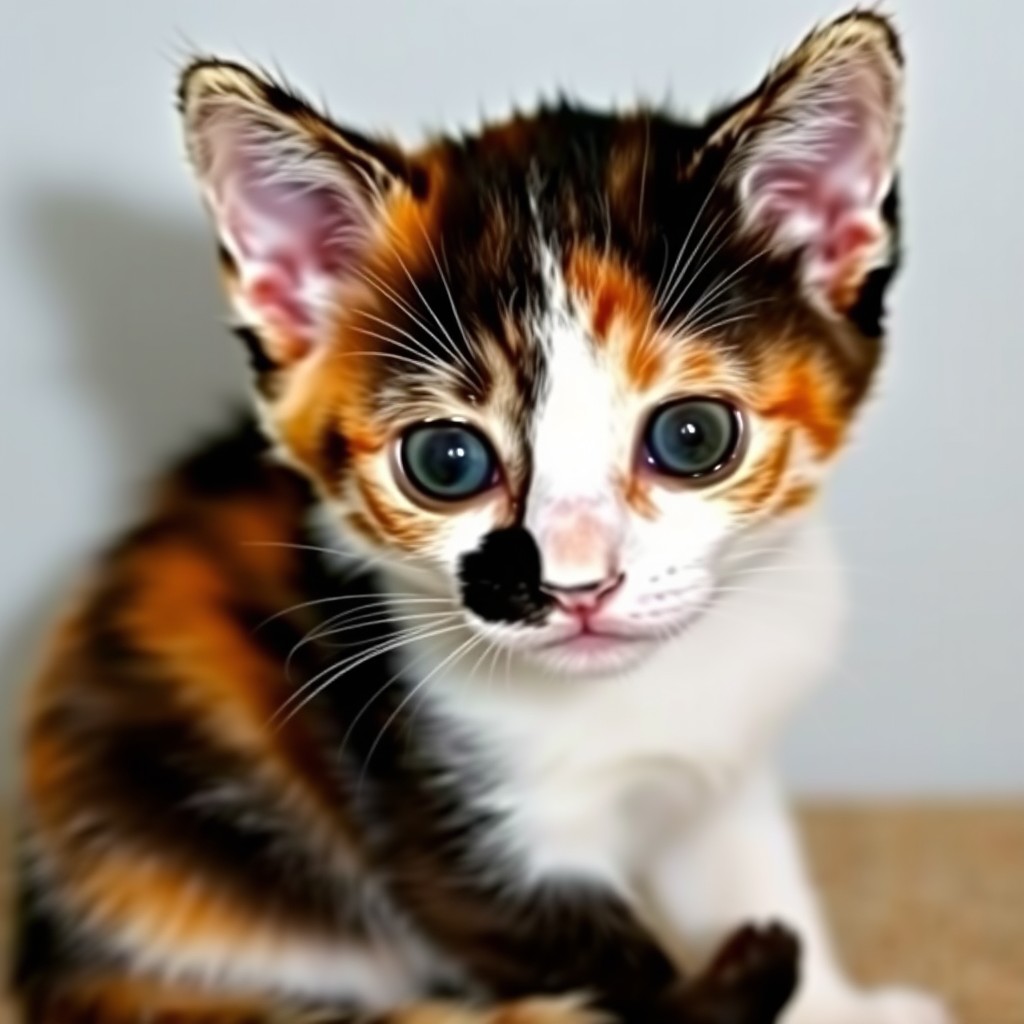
[{"left": 745, "top": 83, "right": 887, "bottom": 301}]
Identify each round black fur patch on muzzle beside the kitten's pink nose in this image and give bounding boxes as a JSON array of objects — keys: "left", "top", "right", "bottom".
[{"left": 459, "top": 526, "right": 551, "bottom": 624}]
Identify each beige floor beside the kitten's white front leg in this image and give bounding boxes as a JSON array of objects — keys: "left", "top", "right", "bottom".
[{"left": 0, "top": 803, "right": 1024, "bottom": 1024}]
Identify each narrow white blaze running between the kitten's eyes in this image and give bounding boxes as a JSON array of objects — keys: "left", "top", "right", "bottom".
[{"left": 525, "top": 235, "right": 629, "bottom": 582}]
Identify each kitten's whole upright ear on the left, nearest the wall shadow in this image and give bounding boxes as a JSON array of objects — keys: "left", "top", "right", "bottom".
[{"left": 179, "top": 60, "right": 407, "bottom": 367}]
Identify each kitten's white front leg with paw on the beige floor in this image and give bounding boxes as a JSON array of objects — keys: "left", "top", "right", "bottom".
[{"left": 651, "top": 772, "right": 948, "bottom": 1024}]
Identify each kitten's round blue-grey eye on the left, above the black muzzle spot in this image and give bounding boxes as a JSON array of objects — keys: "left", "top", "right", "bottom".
[{"left": 399, "top": 421, "right": 498, "bottom": 502}]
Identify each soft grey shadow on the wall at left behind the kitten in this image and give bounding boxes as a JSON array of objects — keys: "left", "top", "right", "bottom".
[{"left": 0, "top": 190, "right": 246, "bottom": 778}]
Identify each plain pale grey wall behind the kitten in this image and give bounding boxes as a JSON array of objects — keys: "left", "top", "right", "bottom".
[{"left": 0, "top": 0, "right": 1024, "bottom": 794}]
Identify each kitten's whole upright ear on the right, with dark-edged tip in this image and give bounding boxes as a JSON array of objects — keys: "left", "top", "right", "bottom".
[{"left": 723, "top": 12, "right": 903, "bottom": 312}]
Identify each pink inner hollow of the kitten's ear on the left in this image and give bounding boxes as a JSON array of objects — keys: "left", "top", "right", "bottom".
[{"left": 208, "top": 106, "right": 367, "bottom": 351}]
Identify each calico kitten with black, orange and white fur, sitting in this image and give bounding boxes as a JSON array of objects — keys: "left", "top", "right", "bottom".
[{"left": 16, "top": 12, "right": 944, "bottom": 1024}]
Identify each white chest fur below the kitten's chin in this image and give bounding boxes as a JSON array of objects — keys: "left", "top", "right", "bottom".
[{"left": 411, "top": 522, "right": 843, "bottom": 895}]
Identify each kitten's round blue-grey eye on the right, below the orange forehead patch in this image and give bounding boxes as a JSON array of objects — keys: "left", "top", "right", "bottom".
[{"left": 644, "top": 398, "right": 742, "bottom": 480}]
